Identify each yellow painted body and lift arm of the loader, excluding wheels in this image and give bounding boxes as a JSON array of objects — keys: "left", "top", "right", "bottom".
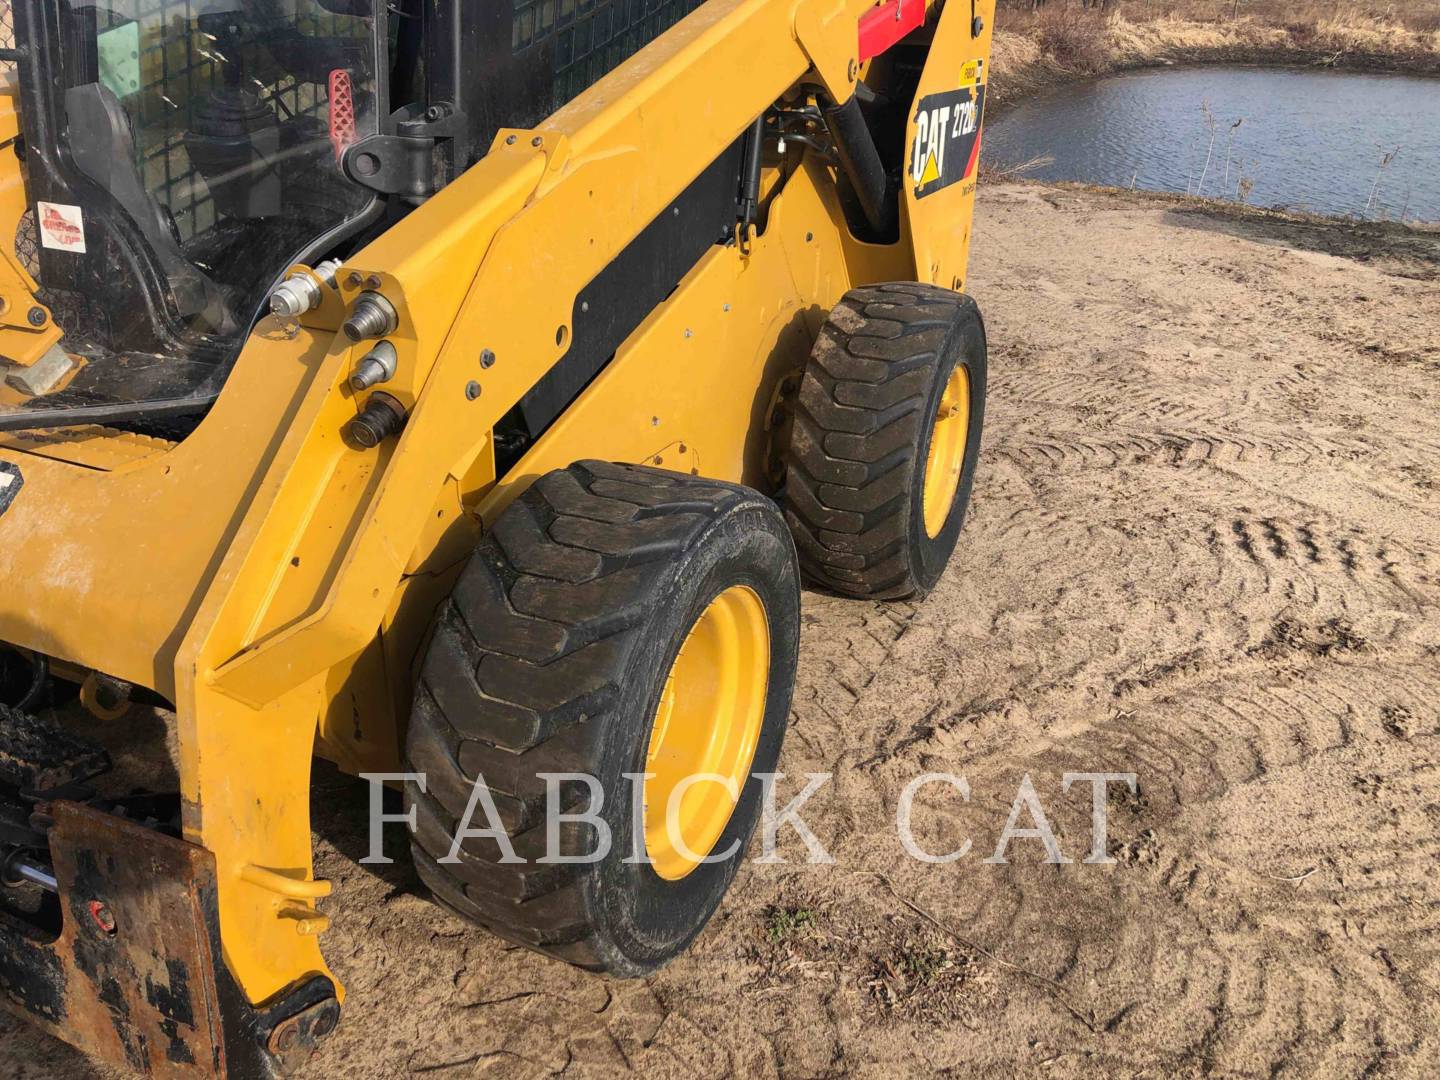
[{"left": 0, "top": 0, "right": 994, "bottom": 1042}]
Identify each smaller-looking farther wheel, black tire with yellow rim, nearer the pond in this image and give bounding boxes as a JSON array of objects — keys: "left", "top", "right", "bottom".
[{"left": 785, "top": 282, "right": 986, "bottom": 599}]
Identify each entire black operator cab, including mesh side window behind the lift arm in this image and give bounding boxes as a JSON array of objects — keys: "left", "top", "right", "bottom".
[{"left": 0, "top": 0, "right": 703, "bottom": 439}]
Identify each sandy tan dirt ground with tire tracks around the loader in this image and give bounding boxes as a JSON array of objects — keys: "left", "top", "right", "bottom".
[{"left": 0, "top": 186, "right": 1440, "bottom": 1077}]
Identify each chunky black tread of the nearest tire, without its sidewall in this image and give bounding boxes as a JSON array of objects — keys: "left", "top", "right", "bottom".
[{"left": 406, "top": 461, "right": 756, "bottom": 971}]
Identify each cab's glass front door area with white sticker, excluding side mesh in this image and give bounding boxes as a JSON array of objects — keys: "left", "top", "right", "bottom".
[{"left": 0, "top": 0, "right": 384, "bottom": 428}]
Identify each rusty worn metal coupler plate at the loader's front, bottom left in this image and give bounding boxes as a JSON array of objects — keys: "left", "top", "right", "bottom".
[{"left": 0, "top": 801, "right": 340, "bottom": 1077}]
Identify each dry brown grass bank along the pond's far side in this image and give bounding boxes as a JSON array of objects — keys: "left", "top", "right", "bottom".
[{"left": 991, "top": 0, "right": 1440, "bottom": 102}]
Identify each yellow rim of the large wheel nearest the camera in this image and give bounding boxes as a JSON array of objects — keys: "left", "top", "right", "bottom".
[{"left": 644, "top": 585, "right": 770, "bottom": 881}]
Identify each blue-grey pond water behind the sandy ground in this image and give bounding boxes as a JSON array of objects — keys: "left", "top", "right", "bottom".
[{"left": 982, "top": 66, "right": 1440, "bottom": 220}]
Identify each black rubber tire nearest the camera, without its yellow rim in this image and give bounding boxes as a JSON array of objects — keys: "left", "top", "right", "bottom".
[{"left": 406, "top": 462, "right": 799, "bottom": 976}]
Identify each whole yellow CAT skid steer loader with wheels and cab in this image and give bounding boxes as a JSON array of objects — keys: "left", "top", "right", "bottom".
[{"left": 0, "top": 0, "right": 994, "bottom": 1076}]
